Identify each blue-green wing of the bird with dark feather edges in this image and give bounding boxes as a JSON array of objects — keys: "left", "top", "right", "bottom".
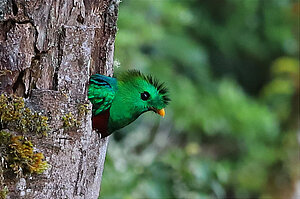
[{"left": 88, "top": 74, "right": 117, "bottom": 115}]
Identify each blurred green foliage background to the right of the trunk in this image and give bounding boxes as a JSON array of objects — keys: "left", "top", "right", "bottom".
[{"left": 101, "top": 0, "right": 300, "bottom": 199}]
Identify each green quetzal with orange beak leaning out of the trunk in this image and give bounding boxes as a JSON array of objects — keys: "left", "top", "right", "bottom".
[{"left": 88, "top": 70, "right": 170, "bottom": 138}]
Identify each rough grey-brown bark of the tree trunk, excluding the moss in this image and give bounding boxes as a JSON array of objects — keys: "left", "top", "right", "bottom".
[{"left": 0, "top": 0, "right": 119, "bottom": 199}]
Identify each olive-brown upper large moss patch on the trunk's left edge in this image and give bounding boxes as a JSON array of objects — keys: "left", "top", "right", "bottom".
[{"left": 0, "top": 94, "right": 48, "bottom": 135}]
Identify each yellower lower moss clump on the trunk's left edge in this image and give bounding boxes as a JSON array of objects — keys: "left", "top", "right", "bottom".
[{"left": 0, "top": 131, "right": 48, "bottom": 175}]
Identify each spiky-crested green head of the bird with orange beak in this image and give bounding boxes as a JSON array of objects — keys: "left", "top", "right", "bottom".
[{"left": 118, "top": 70, "right": 170, "bottom": 117}]
